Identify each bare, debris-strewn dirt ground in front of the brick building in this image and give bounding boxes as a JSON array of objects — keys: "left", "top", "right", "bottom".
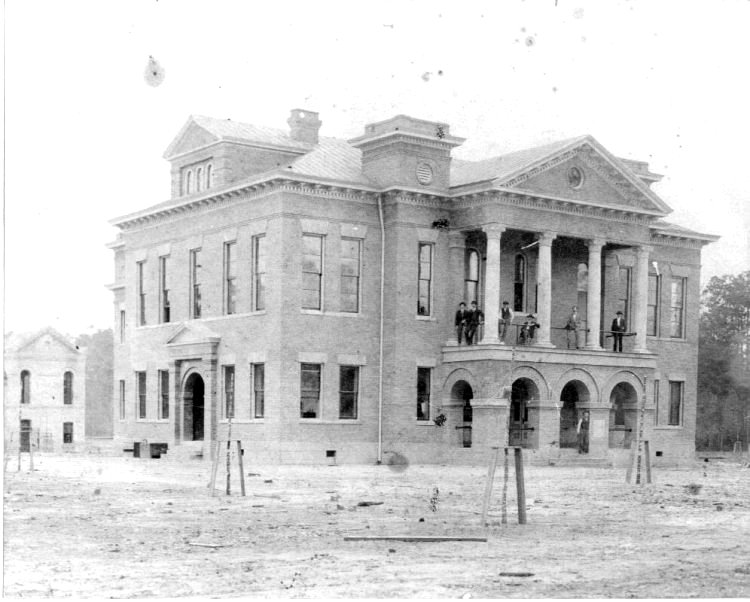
[{"left": 3, "top": 455, "right": 750, "bottom": 598}]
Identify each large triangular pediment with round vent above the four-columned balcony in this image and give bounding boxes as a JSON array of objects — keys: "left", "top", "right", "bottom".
[{"left": 495, "top": 136, "right": 671, "bottom": 215}]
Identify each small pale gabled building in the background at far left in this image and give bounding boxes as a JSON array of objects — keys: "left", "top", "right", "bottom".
[{"left": 4, "top": 328, "right": 86, "bottom": 453}]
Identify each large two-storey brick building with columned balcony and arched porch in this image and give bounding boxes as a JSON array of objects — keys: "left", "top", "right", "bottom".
[{"left": 110, "top": 110, "right": 715, "bottom": 464}]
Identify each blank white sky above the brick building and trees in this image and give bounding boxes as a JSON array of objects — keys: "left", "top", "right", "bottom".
[{"left": 5, "top": 0, "right": 750, "bottom": 334}]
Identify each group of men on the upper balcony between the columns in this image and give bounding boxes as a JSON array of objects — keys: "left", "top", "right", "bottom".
[{"left": 455, "top": 301, "right": 627, "bottom": 353}]
